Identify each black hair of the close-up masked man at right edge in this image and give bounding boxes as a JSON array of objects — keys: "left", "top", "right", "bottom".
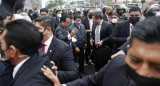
[{"left": 131, "top": 17, "right": 160, "bottom": 45}]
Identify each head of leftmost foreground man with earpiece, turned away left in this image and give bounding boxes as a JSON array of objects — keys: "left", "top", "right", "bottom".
[{"left": 0, "top": 20, "right": 41, "bottom": 66}]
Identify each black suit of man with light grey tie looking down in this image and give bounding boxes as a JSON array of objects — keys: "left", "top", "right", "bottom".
[{"left": 91, "top": 21, "right": 112, "bottom": 71}]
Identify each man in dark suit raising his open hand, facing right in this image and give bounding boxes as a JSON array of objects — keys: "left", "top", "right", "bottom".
[{"left": 54, "top": 15, "right": 77, "bottom": 45}]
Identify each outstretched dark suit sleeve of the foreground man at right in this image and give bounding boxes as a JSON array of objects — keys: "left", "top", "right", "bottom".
[{"left": 66, "top": 56, "right": 122, "bottom": 86}]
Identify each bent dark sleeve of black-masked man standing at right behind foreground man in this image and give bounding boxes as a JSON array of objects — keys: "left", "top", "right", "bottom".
[{"left": 111, "top": 24, "right": 127, "bottom": 44}]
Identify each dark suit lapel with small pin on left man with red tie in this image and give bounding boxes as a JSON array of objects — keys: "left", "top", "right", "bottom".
[{"left": 47, "top": 36, "right": 57, "bottom": 59}]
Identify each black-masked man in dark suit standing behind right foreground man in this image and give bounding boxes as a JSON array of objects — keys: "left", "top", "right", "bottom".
[{"left": 111, "top": 7, "right": 141, "bottom": 54}]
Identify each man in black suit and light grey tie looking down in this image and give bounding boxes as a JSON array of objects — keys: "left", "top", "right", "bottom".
[{"left": 90, "top": 12, "right": 112, "bottom": 71}]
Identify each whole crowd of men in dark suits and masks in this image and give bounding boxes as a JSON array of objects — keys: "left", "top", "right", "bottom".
[{"left": 0, "top": 5, "right": 160, "bottom": 86}]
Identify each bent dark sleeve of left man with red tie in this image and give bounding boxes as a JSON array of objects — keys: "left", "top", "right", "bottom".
[{"left": 58, "top": 46, "right": 79, "bottom": 83}]
